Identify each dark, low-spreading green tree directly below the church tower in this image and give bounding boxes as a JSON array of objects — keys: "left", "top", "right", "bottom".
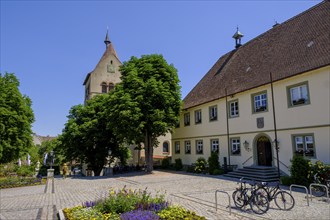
[{"left": 57, "top": 95, "right": 128, "bottom": 176}]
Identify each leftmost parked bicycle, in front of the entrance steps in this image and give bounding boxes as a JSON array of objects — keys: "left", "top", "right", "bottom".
[{"left": 232, "top": 182, "right": 269, "bottom": 214}]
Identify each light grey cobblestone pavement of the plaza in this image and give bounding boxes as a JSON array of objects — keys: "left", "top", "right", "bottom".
[{"left": 0, "top": 171, "right": 330, "bottom": 220}]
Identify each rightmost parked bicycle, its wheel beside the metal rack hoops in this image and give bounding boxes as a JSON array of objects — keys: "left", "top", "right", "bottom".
[{"left": 256, "top": 182, "right": 295, "bottom": 211}]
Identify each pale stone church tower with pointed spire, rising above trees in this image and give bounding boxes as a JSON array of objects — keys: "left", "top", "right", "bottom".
[{"left": 83, "top": 32, "right": 121, "bottom": 102}]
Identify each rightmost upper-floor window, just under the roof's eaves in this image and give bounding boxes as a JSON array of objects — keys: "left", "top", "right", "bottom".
[{"left": 288, "top": 82, "right": 310, "bottom": 107}]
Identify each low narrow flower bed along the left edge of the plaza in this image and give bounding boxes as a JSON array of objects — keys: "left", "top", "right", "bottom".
[{"left": 0, "top": 176, "right": 46, "bottom": 189}]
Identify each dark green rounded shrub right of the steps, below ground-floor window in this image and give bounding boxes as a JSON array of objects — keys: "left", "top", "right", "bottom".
[{"left": 290, "top": 155, "right": 310, "bottom": 186}]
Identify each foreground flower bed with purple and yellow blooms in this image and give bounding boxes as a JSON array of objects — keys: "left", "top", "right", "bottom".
[{"left": 63, "top": 187, "right": 205, "bottom": 220}]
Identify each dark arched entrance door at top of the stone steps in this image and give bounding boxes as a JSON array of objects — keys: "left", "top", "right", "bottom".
[{"left": 257, "top": 136, "right": 273, "bottom": 166}]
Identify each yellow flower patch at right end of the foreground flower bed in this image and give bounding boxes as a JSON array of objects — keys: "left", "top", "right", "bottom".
[{"left": 158, "top": 206, "right": 206, "bottom": 220}]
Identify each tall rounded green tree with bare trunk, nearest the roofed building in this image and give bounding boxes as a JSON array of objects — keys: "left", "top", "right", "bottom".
[{"left": 108, "top": 54, "right": 181, "bottom": 172}]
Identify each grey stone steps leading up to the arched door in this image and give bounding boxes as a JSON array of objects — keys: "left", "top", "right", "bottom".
[{"left": 224, "top": 166, "right": 279, "bottom": 182}]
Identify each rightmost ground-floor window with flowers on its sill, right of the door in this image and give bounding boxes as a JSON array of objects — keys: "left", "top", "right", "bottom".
[{"left": 293, "top": 134, "right": 315, "bottom": 157}]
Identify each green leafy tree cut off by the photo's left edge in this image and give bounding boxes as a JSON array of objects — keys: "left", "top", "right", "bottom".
[{"left": 0, "top": 73, "right": 34, "bottom": 163}]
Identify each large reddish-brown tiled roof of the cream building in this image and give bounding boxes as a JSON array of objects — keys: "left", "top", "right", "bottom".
[{"left": 183, "top": 0, "right": 330, "bottom": 109}]
